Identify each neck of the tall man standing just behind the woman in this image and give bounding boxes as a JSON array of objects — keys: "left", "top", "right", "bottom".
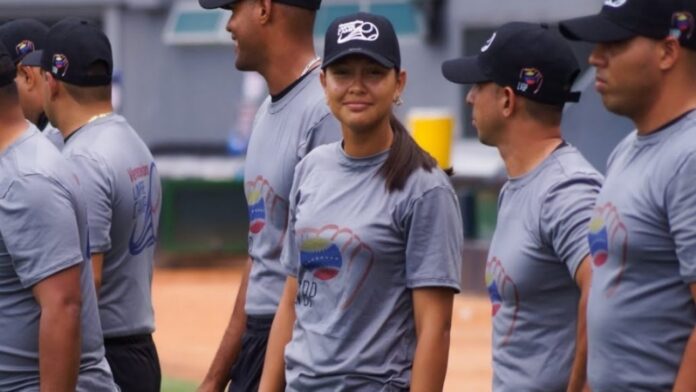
[{"left": 259, "top": 45, "right": 319, "bottom": 95}]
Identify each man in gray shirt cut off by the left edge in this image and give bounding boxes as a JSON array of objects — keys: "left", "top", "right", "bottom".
[{"left": 0, "top": 43, "right": 118, "bottom": 392}]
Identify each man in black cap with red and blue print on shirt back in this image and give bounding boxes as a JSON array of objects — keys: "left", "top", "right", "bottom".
[{"left": 41, "top": 18, "right": 162, "bottom": 392}]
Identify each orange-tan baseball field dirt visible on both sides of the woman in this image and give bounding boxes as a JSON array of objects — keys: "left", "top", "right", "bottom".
[{"left": 153, "top": 262, "right": 491, "bottom": 392}]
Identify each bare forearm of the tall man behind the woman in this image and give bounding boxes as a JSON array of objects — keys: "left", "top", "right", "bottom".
[{"left": 198, "top": 261, "right": 251, "bottom": 392}]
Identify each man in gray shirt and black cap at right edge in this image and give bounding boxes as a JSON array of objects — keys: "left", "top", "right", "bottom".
[{"left": 561, "top": 0, "right": 696, "bottom": 392}]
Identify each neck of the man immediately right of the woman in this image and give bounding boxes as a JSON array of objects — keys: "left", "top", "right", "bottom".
[{"left": 497, "top": 124, "right": 563, "bottom": 178}]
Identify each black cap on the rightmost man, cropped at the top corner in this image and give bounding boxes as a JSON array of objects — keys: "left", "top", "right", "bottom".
[{"left": 560, "top": 0, "right": 696, "bottom": 48}]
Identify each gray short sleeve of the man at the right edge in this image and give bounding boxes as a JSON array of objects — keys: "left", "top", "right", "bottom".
[{"left": 665, "top": 153, "right": 696, "bottom": 284}]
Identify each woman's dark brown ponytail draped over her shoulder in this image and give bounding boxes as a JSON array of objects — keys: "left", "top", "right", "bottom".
[{"left": 378, "top": 114, "right": 437, "bottom": 192}]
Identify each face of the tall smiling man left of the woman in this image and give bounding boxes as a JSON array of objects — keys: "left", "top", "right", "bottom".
[{"left": 226, "top": 0, "right": 263, "bottom": 71}]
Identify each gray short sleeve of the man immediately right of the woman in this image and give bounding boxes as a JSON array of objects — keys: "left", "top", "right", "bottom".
[{"left": 539, "top": 174, "right": 602, "bottom": 277}]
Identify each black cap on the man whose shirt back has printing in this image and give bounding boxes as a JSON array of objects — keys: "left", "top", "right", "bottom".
[{"left": 41, "top": 18, "right": 114, "bottom": 87}]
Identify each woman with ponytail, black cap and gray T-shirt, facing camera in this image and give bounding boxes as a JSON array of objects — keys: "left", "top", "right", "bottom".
[{"left": 260, "top": 13, "right": 463, "bottom": 392}]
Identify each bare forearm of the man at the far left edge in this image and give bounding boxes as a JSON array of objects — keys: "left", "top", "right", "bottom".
[{"left": 39, "top": 302, "right": 81, "bottom": 392}]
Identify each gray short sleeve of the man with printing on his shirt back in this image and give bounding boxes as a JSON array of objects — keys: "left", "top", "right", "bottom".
[{"left": 70, "top": 155, "right": 113, "bottom": 253}]
